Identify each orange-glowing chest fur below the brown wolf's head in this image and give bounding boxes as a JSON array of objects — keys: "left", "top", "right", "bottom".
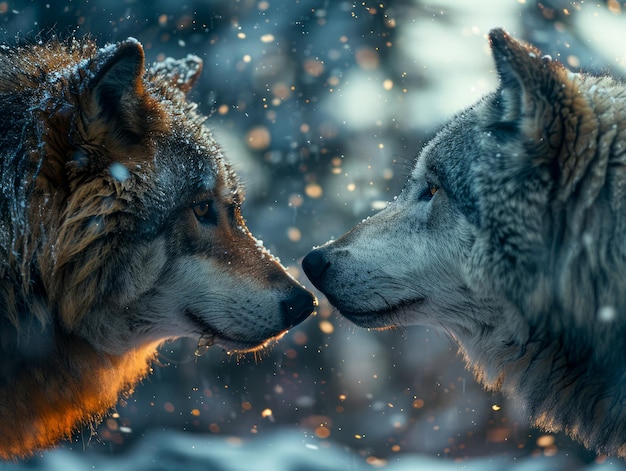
[{"left": 0, "top": 340, "right": 158, "bottom": 459}]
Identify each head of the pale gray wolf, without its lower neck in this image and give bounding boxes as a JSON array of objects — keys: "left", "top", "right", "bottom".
[{"left": 303, "top": 26, "right": 626, "bottom": 340}]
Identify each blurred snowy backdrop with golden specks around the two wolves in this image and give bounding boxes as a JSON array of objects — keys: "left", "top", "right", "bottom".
[{"left": 0, "top": 0, "right": 626, "bottom": 470}]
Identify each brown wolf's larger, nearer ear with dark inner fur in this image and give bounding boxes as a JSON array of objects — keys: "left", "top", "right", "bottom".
[{"left": 83, "top": 38, "right": 154, "bottom": 142}]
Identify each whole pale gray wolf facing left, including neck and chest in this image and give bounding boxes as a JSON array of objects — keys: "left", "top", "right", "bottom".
[{"left": 303, "top": 30, "right": 626, "bottom": 457}]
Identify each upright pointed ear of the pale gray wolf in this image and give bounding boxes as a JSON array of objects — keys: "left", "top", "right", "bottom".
[{"left": 489, "top": 29, "right": 564, "bottom": 129}]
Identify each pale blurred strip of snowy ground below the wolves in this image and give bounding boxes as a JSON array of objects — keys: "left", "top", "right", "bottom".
[{"left": 0, "top": 429, "right": 626, "bottom": 471}]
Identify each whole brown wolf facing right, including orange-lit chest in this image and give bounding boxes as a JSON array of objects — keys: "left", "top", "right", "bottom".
[{"left": 0, "top": 38, "right": 316, "bottom": 459}]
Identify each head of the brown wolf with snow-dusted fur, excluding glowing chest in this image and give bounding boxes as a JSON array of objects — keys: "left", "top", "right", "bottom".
[{"left": 0, "top": 39, "right": 315, "bottom": 354}]
